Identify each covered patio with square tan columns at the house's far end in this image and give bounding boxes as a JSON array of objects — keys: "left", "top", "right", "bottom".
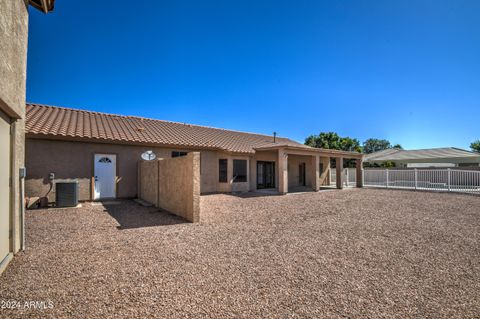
[{"left": 255, "top": 145, "right": 364, "bottom": 194}]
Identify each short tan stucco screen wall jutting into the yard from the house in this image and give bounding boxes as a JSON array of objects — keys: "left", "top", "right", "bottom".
[{"left": 140, "top": 152, "right": 200, "bottom": 223}]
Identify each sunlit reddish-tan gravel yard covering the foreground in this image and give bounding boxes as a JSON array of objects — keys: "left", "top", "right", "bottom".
[{"left": 0, "top": 189, "right": 480, "bottom": 318}]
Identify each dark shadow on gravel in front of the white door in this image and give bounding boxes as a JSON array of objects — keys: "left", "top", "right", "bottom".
[{"left": 104, "top": 201, "right": 188, "bottom": 230}]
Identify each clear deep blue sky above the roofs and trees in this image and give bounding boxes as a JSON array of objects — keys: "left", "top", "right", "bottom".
[{"left": 27, "top": 0, "right": 480, "bottom": 149}]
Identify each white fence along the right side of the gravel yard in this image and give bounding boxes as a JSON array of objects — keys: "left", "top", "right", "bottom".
[{"left": 363, "top": 168, "right": 480, "bottom": 194}]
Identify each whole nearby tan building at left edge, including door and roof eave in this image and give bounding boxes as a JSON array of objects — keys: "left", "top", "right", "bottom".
[{"left": 0, "top": 0, "right": 54, "bottom": 272}]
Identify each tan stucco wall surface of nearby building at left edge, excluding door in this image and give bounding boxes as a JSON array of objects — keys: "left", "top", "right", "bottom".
[{"left": 0, "top": 0, "right": 28, "bottom": 258}]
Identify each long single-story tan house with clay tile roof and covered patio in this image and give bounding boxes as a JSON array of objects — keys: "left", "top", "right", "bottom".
[{"left": 26, "top": 104, "right": 363, "bottom": 202}]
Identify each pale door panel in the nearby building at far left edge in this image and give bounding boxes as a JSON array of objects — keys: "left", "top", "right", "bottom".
[{"left": 0, "top": 111, "right": 12, "bottom": 262}]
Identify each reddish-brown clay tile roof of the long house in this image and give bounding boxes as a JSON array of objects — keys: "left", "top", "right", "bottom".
[{"left": 25, "top": 103, "right": 308, "bottom": 153}]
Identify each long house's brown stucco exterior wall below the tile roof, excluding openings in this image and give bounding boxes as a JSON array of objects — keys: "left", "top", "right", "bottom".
[{"left": 26, "top": 138, "right": 336, "bottom": 202}]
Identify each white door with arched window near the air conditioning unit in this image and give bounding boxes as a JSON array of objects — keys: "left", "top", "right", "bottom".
[{"left": 94, "top": 154, "right": 117, "bottom": 199}]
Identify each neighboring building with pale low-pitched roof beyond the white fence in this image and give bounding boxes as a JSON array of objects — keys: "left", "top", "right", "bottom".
[{"left": 364, "top": 147, "right": 480, "bottom": 168}]
